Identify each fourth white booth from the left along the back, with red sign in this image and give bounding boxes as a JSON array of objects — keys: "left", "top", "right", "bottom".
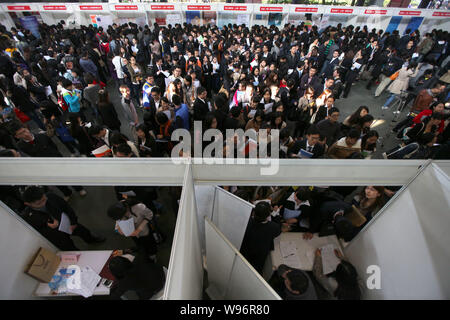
[{"left": 109, "top": 3, "right": 148, "bottom": 27}]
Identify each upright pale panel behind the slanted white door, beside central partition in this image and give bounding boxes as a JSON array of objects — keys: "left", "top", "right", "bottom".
[{"left": 211, "top": 187, "right": 254, "bottom": 250}]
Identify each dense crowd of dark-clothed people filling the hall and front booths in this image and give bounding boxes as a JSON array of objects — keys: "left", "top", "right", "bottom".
[{"left": 0, "top": 17, "right": 450, "bottom": 299}]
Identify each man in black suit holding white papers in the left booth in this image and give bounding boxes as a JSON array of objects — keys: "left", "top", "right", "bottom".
[{"left": 23, "top": 186, "right": 105, "bottom": 251}]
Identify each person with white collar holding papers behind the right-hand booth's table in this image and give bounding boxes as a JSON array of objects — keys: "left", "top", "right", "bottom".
[{"left": 281, "top": 187, "right": 312, "bottom": 232}]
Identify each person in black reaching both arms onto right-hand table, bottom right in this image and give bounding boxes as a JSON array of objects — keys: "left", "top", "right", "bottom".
[{"left": 313, "top": 249, "right": 361, "bottom": 300}]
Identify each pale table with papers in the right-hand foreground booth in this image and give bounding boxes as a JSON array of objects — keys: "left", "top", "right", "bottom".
[{"left": 263, "top": 232, "right": 344, "bottom": 280}]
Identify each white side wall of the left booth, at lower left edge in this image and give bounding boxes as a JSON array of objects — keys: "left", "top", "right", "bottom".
[{"left": 0, "top": 201, "right": 57, "bottom": 300}]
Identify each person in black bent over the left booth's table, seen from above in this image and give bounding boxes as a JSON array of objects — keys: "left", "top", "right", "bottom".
[{"left": 108, "top": 250, "right": 166, "bottom": 300}]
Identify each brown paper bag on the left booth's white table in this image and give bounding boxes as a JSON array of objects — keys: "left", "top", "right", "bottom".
[{"left": 25, "top": 248, "right": 61, "bottom": 283}]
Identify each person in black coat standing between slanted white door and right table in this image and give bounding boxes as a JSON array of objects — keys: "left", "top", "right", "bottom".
[{"left": 240, "top": 202, "right": 281, "bottom": 273}]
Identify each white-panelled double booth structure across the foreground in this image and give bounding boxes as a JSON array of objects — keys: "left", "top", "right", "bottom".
[{"left": 0, "top": 158, "right": 450, "bottom": 300}]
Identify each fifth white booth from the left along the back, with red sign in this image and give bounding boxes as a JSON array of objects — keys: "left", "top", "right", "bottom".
[{"left": 145, "top": 3, "right": 183, "bottom": 27}]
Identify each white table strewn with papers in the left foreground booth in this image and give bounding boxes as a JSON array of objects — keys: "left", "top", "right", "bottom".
[{"left": 34, "top": 250, "right": 113, "bottom": 297}]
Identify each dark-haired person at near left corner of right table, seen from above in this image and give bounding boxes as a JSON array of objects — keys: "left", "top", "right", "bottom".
[{"left": 269, "top": 264, "right": 317, "bottom": 300}]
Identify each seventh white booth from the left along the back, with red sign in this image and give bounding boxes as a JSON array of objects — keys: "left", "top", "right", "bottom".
[{"left": 218, "top": 3, "right": 253, "bottom": 28}]
